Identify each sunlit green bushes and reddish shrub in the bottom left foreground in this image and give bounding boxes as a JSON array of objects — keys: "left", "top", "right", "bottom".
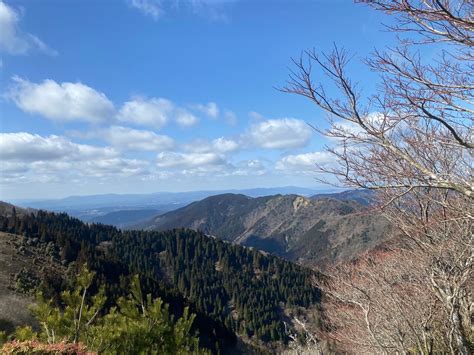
[{"left": 2, "top": 267, "right": 206, "bottom": 354}]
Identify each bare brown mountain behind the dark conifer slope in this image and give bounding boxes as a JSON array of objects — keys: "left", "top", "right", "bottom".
[{"left": 137, "top": 194, "right": 388, "bottom": 266}]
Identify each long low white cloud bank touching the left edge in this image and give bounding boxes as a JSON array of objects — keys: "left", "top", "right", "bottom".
[{"left": 0, "top": 132, "right": 149, "bottom": 183}]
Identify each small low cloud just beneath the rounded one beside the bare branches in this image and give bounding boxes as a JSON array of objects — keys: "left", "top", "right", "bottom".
[{"left": 275, "top": 152, "right": 335, "bottom": 173}]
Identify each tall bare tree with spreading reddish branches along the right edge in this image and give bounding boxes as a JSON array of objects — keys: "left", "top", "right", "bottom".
[{"left": 284, "top": 0, "right": 474, "bottom": 354}]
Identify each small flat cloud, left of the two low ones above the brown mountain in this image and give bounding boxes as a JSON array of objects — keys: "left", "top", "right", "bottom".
[{"left": 156, "top": 152, "right": 225, "bottom": 169}]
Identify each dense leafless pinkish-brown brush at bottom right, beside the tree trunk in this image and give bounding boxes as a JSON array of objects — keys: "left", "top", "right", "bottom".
[{"left": 319, "top": 249, "right": 447, "bottom": 354}]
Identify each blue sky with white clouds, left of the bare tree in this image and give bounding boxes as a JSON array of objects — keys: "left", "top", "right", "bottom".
[{"left": 0, "top": 0, "right": 393, "bottom": 200}]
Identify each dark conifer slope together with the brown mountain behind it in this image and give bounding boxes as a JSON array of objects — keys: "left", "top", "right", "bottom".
[{"left": 0, "top": 191, "right": 391, "bottom": 353}]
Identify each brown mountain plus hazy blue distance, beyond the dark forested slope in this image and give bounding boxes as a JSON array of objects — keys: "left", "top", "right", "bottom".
[{"left": 4, "top": 187, "right": 390, "bottom": 267}]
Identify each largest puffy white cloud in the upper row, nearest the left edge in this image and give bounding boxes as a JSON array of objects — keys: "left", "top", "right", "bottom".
[{"left": 8, "top": 77, "right": 114, "bottom": 123}]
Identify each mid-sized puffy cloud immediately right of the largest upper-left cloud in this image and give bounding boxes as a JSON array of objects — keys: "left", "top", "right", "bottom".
[{"left": 117, "top": 98, "right": 198, "bottom": 129}]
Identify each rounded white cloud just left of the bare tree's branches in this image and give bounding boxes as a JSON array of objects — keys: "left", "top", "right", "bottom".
[{"left": 244, "top": 118, "right": 312, "bottom": 149}]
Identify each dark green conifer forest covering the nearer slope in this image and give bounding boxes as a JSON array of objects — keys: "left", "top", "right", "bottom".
[{"left": 0, "top": 206, "right": 320, "bottom": 352}]
